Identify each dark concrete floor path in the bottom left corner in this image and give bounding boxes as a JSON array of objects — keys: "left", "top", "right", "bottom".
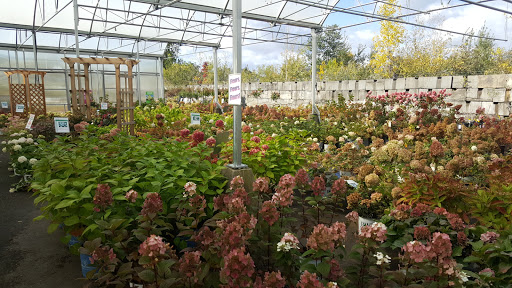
[{"left": 0, "top": 137, "right": 88, "bottom": 288}]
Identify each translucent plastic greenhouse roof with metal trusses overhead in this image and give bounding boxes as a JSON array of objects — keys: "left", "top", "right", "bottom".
[{"left": 0, "top": 0, "right": 339, "bottom": 56}]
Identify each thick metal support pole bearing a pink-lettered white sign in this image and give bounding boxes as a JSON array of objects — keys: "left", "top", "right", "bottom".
[{"left": 228, "top": 0, "right": 247, "bottom": 169}]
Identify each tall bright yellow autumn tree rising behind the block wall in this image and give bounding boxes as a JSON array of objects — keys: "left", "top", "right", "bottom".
[{"left": 370, "top": 0, "right": 405, "bottom": 78}]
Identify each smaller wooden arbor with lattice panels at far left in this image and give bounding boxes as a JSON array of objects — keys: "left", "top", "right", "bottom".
[{"left": 4, "top": 70, "right": 46, "bottom": 116}]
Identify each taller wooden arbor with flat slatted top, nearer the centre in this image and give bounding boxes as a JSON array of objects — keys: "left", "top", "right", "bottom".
[{"left": 62, "top": 57, "right": 139, "bottom": 135}]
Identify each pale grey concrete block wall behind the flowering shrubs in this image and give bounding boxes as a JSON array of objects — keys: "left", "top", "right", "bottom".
[{"left": 188, "top": 74, "right": 512, "bottom": 116}]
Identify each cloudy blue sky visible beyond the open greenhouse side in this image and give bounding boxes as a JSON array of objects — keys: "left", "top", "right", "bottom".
[{"left": 180, "top": 0, "right": 512, "bottom": 69}]
